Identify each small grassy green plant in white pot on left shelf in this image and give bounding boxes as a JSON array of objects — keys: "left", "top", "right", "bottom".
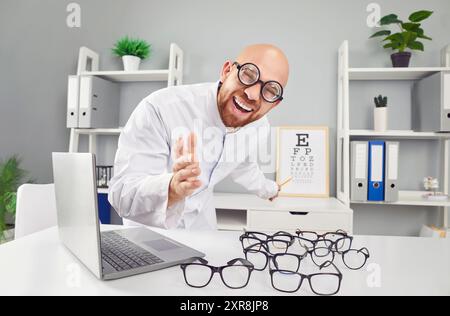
[{"left": 112, "top": 36, "right": 151, "bottom": 71}]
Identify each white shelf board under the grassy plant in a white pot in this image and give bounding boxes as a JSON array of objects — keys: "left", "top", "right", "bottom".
[{"left": 81, "top": 69, "right": 169, "bottom": 82}]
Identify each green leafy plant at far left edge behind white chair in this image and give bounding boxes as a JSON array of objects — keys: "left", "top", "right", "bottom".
[{"left": 0, "top": 156, "right": 27, "bottom": 242}]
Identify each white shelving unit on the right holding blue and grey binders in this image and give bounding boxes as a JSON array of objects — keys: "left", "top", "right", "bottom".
[{"left": 336, "top": 41, "right": 450, "bottom": 227}]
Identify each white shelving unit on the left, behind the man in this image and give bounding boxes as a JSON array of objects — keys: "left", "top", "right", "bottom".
[{"left": 69, "top": 43, "right": 183, "bottom": 153}]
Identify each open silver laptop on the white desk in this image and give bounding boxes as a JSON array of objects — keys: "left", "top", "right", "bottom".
[{"left": 53, "top": 153, "right": 204, "bottom": 280}]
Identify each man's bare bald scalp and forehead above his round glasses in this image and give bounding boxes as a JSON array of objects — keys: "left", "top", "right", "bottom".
[{"left": 236, "top": 44, "right": 289, "bottom": 88}]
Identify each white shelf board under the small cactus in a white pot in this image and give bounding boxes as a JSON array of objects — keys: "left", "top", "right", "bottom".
[{"left": 350, "top": 130, "right": 450, "bottom": 139}]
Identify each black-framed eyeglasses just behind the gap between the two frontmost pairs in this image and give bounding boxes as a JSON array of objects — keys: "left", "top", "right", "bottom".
[{"left": 243, "top": 243, "right": 307, "bottom": 272}]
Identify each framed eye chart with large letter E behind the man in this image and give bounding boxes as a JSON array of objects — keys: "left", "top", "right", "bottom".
[{"left": 276, "top": 126, "right": 330, "bottom": 198}]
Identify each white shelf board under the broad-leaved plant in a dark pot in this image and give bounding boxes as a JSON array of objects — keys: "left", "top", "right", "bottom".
[{"left": 348, "top": 67, "right": 450, "bottom": 80}]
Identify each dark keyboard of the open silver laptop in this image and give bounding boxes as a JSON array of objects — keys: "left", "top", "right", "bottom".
[{"left": 101, "top": 232, "right": 164, "bottom": 272}]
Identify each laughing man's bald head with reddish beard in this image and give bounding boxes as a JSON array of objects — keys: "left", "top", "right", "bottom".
[{"left": 217, "top": 44, "right": 289, "bottom": 127}]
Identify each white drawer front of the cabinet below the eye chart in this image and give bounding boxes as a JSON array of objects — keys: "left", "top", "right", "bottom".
[{"left": 247, "top": 210, "right": 353, "bottom": 233}]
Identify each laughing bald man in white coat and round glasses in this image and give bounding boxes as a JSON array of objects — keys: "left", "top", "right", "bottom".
[{"left": 108, "top": 44, "right": 289, "bottom": 229}]
